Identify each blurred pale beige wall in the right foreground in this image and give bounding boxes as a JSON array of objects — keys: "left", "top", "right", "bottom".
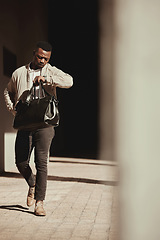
[{"left": 114, "top": 0, "right": 160, "bottom": 240}]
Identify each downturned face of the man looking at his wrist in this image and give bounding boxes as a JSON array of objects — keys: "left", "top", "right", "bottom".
[{"left": 32, "top": 48, "right": 51, "bottom": 69}]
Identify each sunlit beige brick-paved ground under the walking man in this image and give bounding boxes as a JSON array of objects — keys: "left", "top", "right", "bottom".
[{"left": 0, "top": 158, "right": 117, "bottom": 240}]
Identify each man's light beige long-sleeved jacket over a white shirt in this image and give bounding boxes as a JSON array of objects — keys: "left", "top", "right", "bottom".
[{"left": 4, "top": 63, "right": 73, "bottom": 115}]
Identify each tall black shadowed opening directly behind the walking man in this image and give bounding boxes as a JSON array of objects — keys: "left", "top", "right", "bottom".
[{"left": 48, "top": 0, "right": 98, "bottom": 158}]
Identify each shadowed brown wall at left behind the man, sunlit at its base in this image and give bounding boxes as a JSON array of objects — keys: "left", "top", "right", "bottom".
[{"left": 0, "top": 0, "right": 48, "bottom": 172}]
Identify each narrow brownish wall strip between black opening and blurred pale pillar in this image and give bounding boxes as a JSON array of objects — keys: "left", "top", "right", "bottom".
[{"left": 99, "top": 0, "right": 114, "bottom": 160}]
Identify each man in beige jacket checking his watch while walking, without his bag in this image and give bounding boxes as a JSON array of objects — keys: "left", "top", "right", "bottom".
[{"left": 4, "top": 41, "right": 73, "bottom": 216}]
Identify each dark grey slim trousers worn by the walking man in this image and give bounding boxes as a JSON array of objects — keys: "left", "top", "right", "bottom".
[{"left": 15, "top": 127, "right": 54, "bottom": 200}]
